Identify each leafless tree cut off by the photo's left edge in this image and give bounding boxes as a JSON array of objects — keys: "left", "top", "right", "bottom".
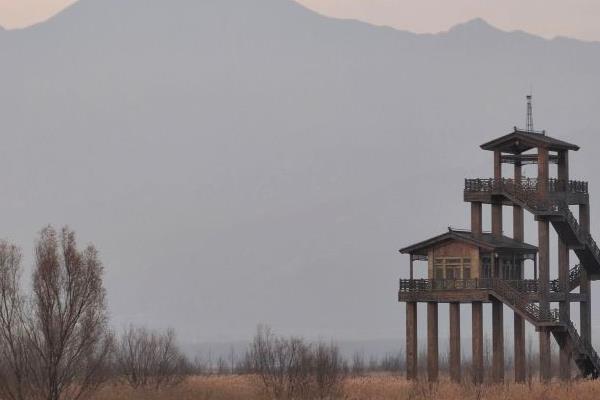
[{"left": 0, "top": 241, "right": 30, "bottom": 400}]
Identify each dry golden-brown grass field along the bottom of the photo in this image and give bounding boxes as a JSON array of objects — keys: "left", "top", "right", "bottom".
[{"left": 94, "top": 375, "right": 600, "bottom": 400}]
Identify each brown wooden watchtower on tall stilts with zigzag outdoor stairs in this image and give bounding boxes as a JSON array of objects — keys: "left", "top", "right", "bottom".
[{"left": 398, "top": 124, "right": 600, "bottom": 383}]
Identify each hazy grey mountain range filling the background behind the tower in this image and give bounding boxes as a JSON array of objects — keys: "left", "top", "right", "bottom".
[{"left": 0, "top": 0, "right": 600, "bottom": 341}]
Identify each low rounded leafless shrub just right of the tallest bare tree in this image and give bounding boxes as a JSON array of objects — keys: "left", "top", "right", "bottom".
[{"left": 116, "top": 327, "right": 191, "bottom": 388}]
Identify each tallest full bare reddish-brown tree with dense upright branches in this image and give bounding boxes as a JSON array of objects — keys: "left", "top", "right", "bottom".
[{"left": 27, "top": 227, "right": 112, "bottom": 400}]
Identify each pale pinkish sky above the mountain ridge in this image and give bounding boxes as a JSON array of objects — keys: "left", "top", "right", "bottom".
[{"left": 0, "top": 0, "right": 600, "bottom": 40}]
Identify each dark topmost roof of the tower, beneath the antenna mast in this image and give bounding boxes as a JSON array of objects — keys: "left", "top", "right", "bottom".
[{"left": 481, "top": 127, "right": 579, "bottom": 154}]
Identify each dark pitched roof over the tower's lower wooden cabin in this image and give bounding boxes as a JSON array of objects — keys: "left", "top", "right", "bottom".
[{"left": 400, "top": 228, "right": 538, "bottom": 256}]
